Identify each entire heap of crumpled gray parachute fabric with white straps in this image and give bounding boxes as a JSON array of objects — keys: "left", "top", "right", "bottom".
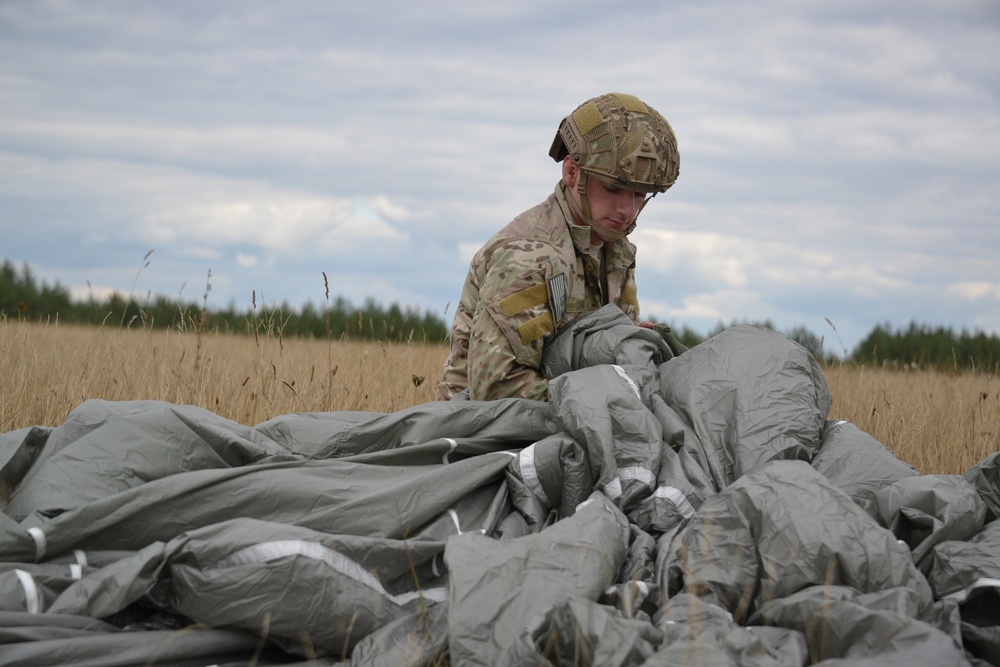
[{"left": 0, "top": 314, "right": 1000, "bottom": 667}]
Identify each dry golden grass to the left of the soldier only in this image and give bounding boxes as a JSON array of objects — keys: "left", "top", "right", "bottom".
[{"left": 0, "top": 312, "right": 447, "bottom": 432}]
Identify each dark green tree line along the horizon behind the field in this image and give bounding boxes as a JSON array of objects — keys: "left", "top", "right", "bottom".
[{"left": 0, "top": 260, "right": 1000, "bottom": 372}]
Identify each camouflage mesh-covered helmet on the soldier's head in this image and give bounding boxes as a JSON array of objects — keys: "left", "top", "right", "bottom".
[{"left": 549, "top": 93, "right": 680, "bottom": 192}]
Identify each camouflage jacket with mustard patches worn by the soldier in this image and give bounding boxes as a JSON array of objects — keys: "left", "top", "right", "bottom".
[{"left": 437, "top": 185, "right": 639, "bottom": 400}]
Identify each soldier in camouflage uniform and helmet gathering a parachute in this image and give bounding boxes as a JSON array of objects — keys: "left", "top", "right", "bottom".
[{"left": 437, "top": 93, "right": 679, "bottom": 400}]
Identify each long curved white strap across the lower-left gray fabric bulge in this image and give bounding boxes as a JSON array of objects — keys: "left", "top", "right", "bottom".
[{"left": 216, "top": 540, "right": 448, "bottom": 606}]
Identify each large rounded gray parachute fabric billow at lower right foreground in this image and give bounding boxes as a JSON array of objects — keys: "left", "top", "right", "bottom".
[{"left": 660, "top": 461, "right": 932, "bottom": 622}]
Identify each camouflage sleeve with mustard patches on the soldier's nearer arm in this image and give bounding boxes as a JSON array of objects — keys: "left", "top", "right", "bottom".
[{"left": 469, "top": 244, "right": 565, "bottom": 400}]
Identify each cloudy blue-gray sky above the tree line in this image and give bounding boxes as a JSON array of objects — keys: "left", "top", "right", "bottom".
[{"left": 0, "top": 0, "right": 1000, "bottom": 352}]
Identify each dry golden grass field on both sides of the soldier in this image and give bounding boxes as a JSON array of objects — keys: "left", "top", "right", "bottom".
[{"left": 0, "top": 321, "right": 1000, "bottom": 474}]
